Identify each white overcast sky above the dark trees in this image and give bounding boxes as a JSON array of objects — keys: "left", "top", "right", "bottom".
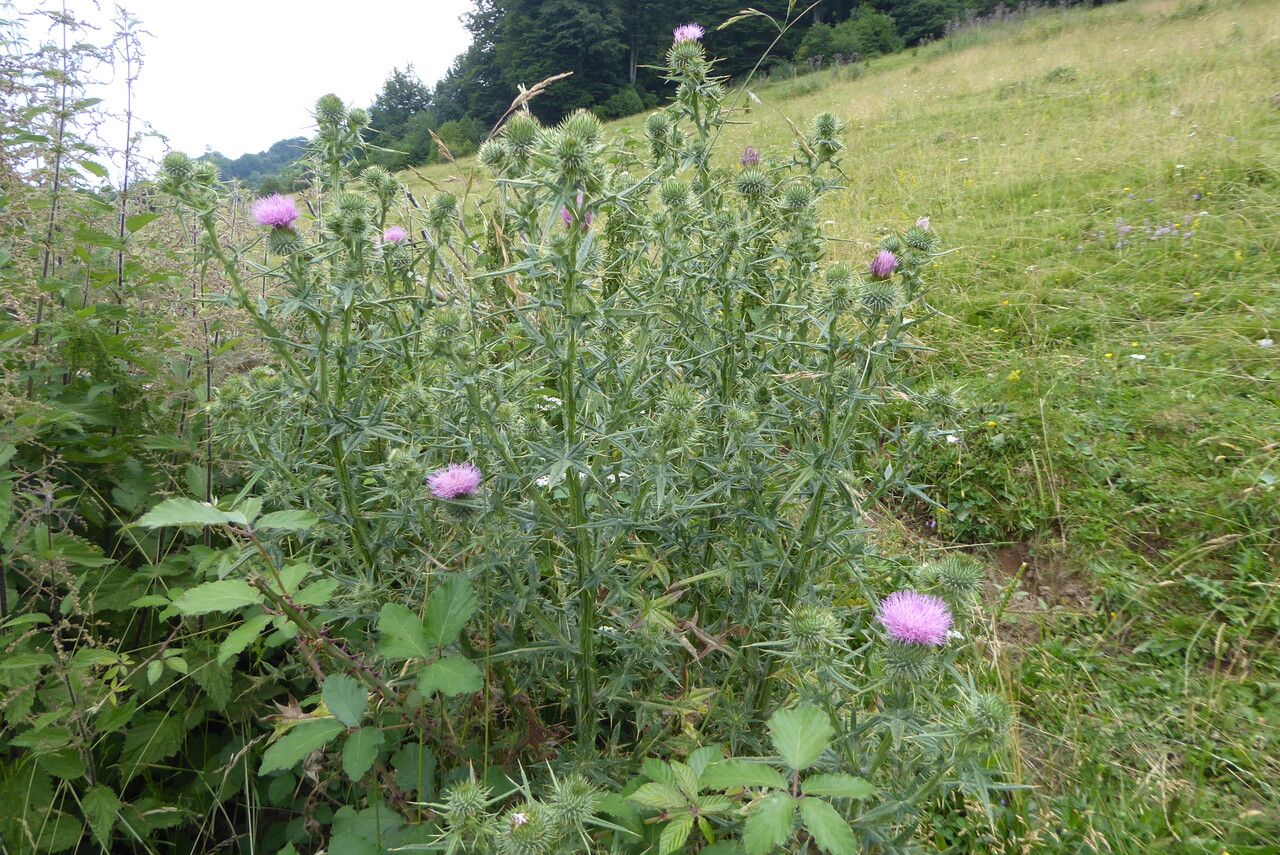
[{"left": 13, "top": 0, "right": 471, "bottom": 157}]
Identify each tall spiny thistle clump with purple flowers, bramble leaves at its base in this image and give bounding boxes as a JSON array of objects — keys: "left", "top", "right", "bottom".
[{"left": 142, "top": 27, "right": 1009, "bottom": 855}]
